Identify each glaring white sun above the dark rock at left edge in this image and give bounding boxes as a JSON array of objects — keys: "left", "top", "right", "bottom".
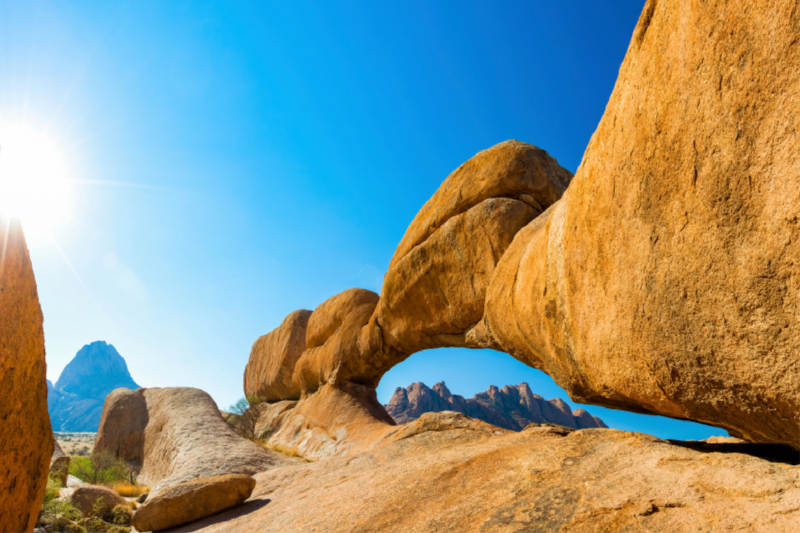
[{"left": 0, "top": 123, "right": 70, "bottom": 244}]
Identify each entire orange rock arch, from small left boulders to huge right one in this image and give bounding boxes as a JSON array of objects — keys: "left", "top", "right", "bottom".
[{"left": 244, "top": 0, "right": 800, "bottom": 449}]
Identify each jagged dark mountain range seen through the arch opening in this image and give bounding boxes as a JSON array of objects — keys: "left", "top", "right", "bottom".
[{"left": 386, "top": 381, "right": 607, "bottom": 431}]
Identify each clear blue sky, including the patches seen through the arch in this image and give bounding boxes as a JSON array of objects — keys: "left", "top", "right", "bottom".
[{"left": 0, "top": 0, "right": 725, "bottom": 438}]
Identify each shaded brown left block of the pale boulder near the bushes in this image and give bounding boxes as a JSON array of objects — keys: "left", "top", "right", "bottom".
[{"left": 94, "top": 388, "right": 149, "bottom": 464}]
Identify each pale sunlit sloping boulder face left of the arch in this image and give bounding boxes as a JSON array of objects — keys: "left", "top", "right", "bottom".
[{"left": 134, "top": 387, "right": 291, "bottom": 495}]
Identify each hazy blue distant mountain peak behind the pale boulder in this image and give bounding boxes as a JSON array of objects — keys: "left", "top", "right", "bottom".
[{"left": 47, "top": 341, "right": 139, "bottom": 432}]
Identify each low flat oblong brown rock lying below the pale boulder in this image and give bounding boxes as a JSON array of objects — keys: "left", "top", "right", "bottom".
[{"left": 131, "top": 474, "right": 256, "bottom": 531}]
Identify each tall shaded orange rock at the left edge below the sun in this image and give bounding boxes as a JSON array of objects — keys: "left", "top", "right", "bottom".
[{"left": 0, "top": 217, "right": 55, "bottom": 531}]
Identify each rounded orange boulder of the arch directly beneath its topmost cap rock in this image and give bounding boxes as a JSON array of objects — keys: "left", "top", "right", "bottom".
[{"left": 375, "top": 197, "right": 537, "bottom": 356}]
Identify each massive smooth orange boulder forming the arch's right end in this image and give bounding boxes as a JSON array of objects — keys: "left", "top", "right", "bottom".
[{"left": 486, "top": 0, "right": 800, "bottom": 448}]
